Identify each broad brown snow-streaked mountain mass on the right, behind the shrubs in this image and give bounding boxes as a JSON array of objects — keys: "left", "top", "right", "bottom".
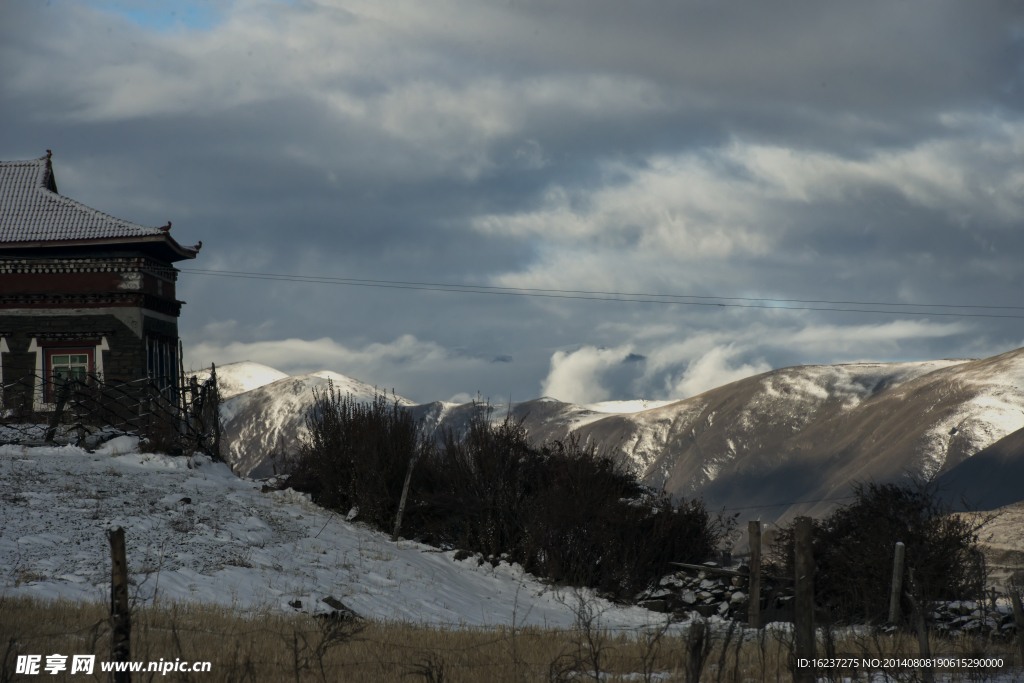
[{"left": 579, "top": 349, "right": 1024, "bottom": 519}]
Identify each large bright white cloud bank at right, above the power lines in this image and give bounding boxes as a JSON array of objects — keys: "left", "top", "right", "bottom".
[{"left": 473, "top": 117, "right": 1024, "bottom": 282}]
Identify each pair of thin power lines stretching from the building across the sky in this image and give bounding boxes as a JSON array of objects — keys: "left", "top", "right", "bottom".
[{"left": 181, "top": 268, "right": 1024, "bottom": 319}]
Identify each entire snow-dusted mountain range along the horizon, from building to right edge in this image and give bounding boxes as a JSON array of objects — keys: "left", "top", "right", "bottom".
[{"left": 207, "top": 349, "right": 1024, "bottom": 520}]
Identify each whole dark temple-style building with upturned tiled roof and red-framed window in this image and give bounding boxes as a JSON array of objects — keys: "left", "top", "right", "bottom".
[{"left": 0, "top": 152, "right": 202, "bottom": 411}]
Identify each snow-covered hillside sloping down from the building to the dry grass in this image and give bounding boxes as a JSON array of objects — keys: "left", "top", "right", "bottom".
[{"left": 0, "top": 436, "right": 660, "bottom": 628}]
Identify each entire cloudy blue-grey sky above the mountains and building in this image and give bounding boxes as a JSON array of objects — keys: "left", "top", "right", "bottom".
[{"left": 0, "top": 0, "right": 1024, "bottom": 402}]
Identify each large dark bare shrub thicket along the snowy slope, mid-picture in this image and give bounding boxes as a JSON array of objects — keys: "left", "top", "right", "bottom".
[{"left": 289, "top": 384, "right": 734, "bottom": 599}]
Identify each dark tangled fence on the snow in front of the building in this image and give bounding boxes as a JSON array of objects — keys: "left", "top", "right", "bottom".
[{"left": 0, "top": 368, "right": 220, "bottom": 458}]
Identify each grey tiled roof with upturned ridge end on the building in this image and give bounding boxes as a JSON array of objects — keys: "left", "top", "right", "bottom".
[{"left": 0, "top": 154, "right": 169, "bottom": 245}]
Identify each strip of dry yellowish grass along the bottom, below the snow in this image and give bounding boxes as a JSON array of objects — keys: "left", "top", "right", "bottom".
[{"left": 0, "top": 598, "right": 1020, "bottom": 683}]
